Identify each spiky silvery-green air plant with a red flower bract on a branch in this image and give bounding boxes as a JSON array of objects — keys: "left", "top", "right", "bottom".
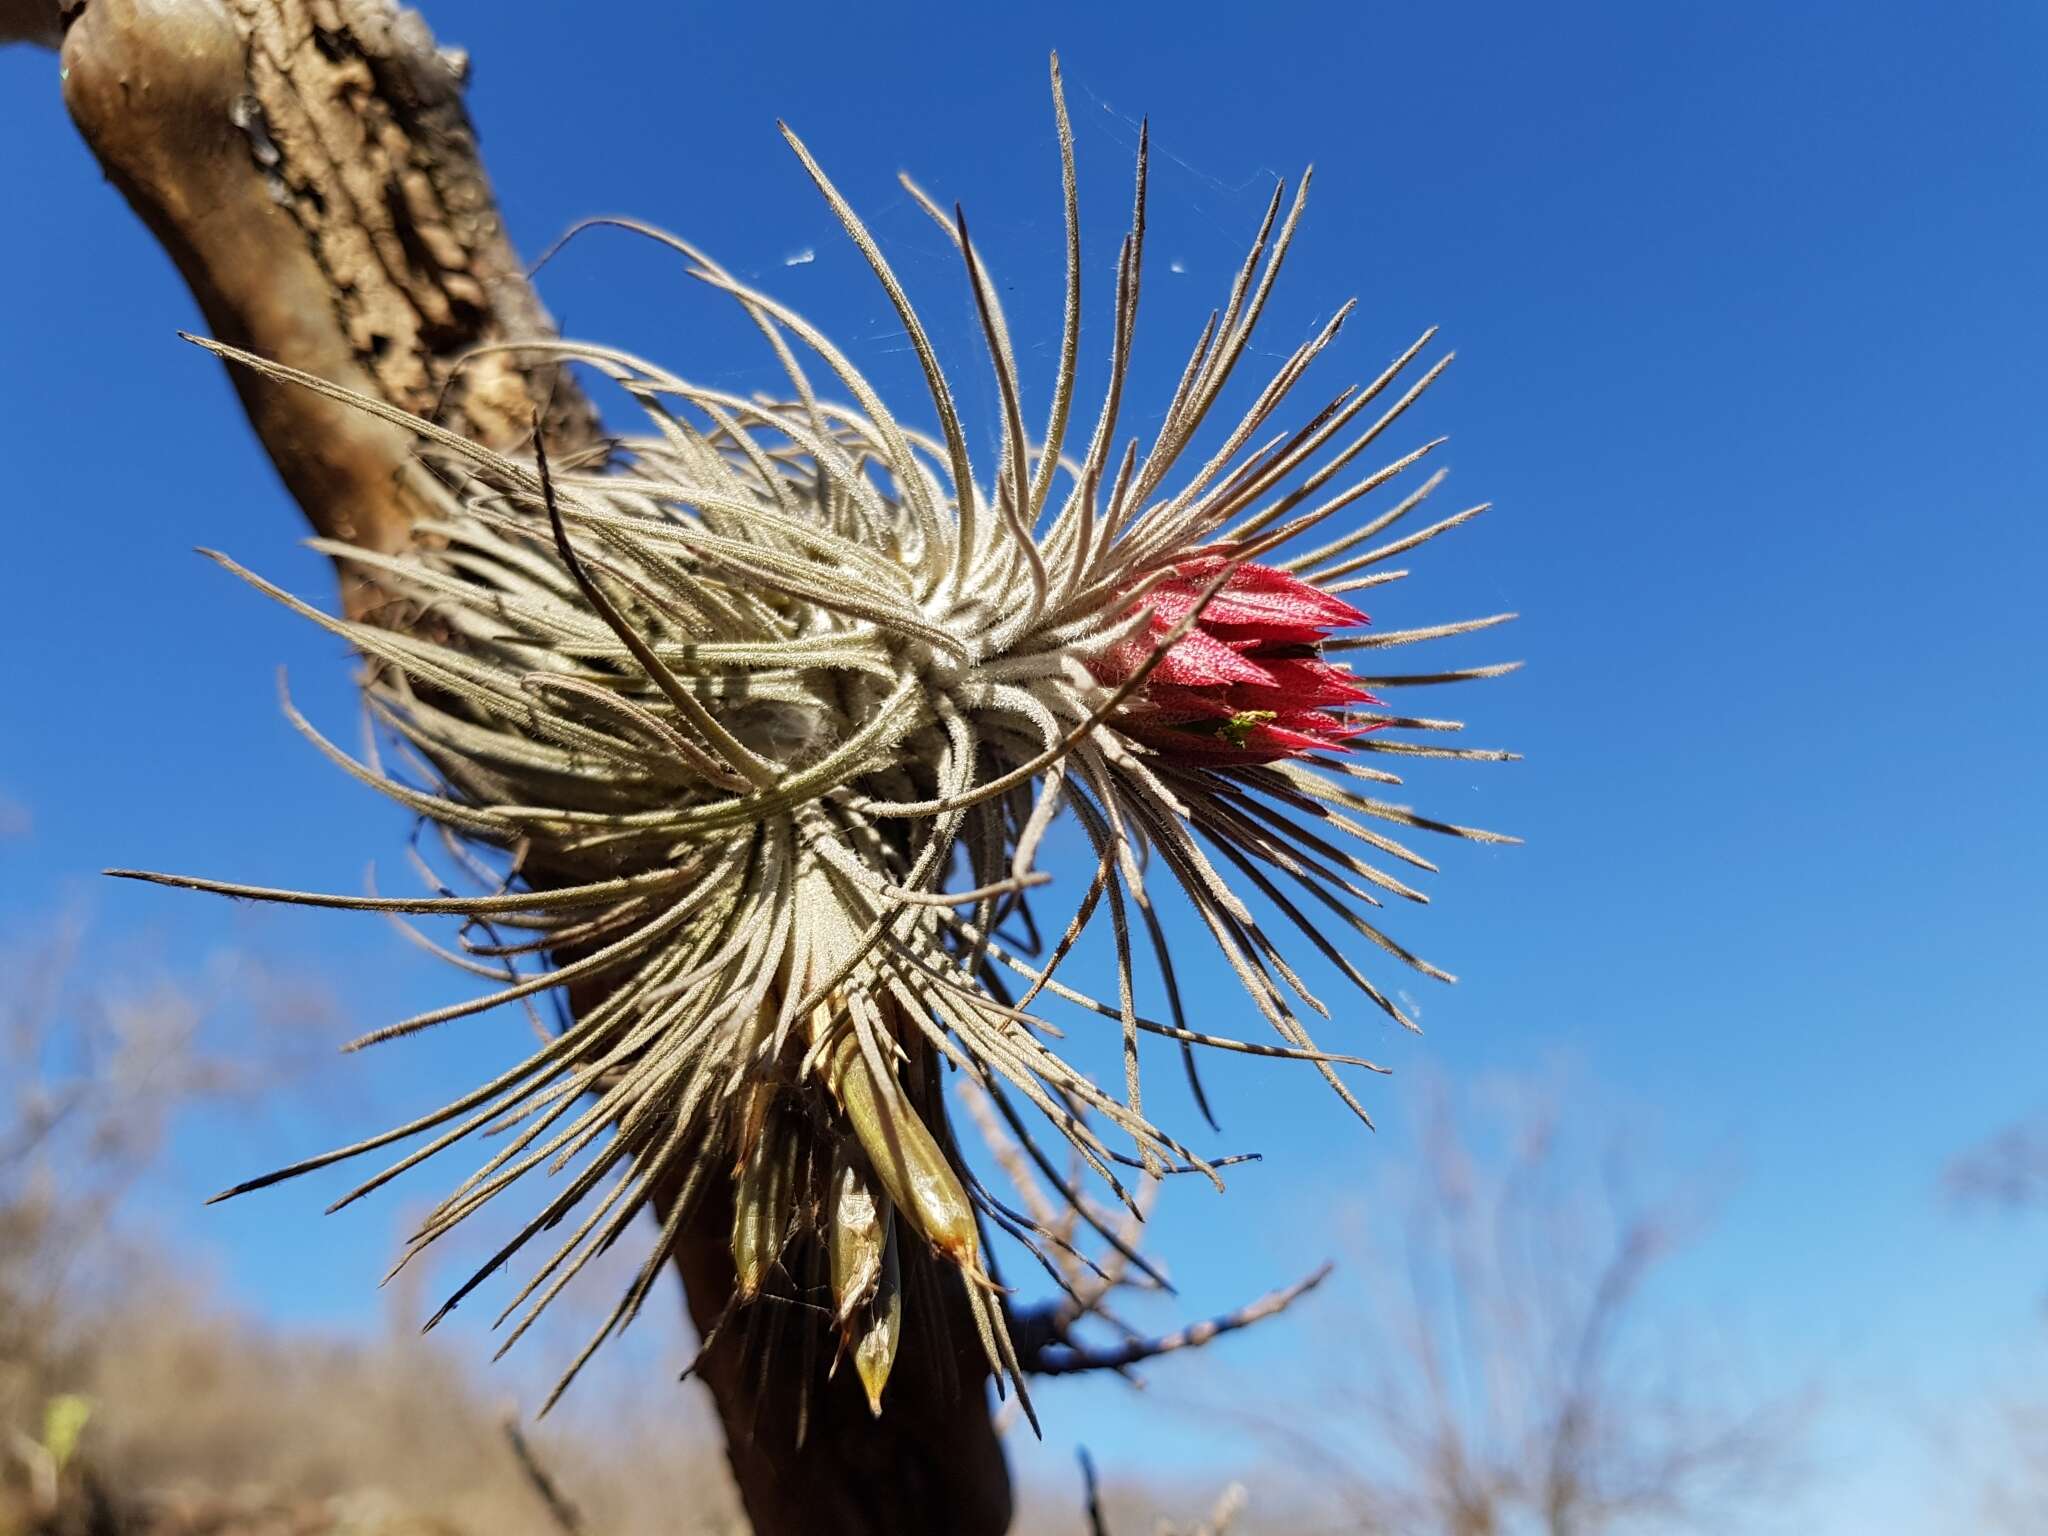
[{"left": 116, "top": 61, "right": 1509, "bottom": 1433}]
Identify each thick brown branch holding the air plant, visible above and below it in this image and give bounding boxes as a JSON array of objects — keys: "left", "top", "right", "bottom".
[{"left": 46, "top": 0, "right": 1010, "bottom": 1536}]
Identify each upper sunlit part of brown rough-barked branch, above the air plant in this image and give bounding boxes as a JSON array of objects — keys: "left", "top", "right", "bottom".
[{"left": 61, "top": 0, "right": 598, "bottom": 614}]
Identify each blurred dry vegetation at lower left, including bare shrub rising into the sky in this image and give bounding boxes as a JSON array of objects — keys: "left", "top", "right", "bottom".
[{"left": 0, "top": 936, "right": 743, "bottom": 1536}]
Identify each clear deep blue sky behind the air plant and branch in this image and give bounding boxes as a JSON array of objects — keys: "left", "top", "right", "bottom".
[{"left": 0, "top": 0, "right": 2048, "bottom": 1530}]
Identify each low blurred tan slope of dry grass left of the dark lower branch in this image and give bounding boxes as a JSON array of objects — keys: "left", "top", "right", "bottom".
[{"left": 12, "top": 1292, "right": 743, "bottom": 1536}]
